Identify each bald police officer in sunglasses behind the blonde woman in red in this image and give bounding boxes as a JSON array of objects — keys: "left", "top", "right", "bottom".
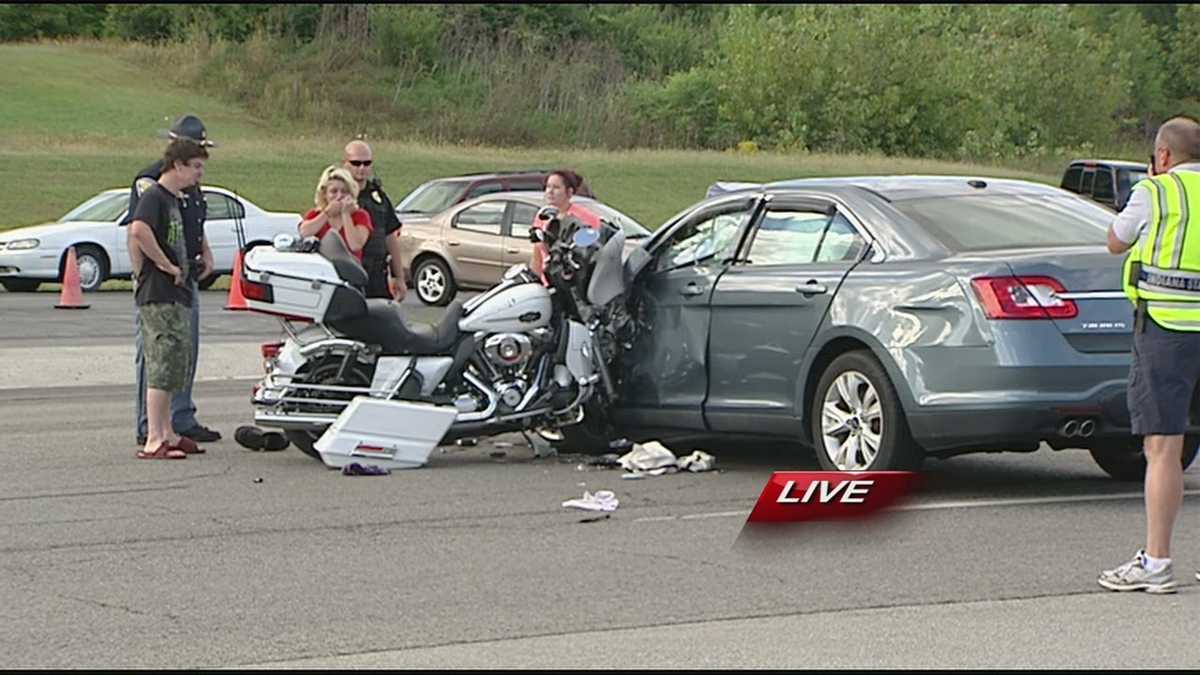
[{"left": 342, "top": 141, "right": 408, "bottom": 301}]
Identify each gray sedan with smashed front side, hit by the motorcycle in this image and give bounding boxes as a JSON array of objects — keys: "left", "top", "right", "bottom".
[{"left": 604, "top": 177, "right": 1200, "bottom": 480}]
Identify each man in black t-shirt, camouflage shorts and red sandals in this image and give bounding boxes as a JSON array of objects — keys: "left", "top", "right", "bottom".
[{"left": 128, "top": 139, "right": 209, "bottom": 459}]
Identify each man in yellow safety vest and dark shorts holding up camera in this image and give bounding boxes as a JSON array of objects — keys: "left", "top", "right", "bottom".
[{"left": 1099, "top": 117, "right": 1200, "bottom": 593}]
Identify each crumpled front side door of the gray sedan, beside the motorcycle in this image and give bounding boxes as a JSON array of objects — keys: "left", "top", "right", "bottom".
[{"left": 622, "top": 197, "right": 761, "bottom": 429}]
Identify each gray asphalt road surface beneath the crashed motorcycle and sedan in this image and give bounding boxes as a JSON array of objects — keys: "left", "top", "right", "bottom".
[{"left": 0, "top": 285, "right": 1200, "bottom": 668}]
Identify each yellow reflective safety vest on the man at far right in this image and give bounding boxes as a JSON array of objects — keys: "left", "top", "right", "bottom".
[{"left": 1124, "top": 171, "right": 1200, "bottom": 331}]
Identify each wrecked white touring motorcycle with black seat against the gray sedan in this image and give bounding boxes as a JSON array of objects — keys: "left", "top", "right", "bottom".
[{"left": 241, "top": 208, "right": 628, "bottom": 459}]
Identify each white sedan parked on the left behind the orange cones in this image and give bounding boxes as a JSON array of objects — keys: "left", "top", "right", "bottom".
[{"left": 0, "top": 185, "right": 300, "bottom": 292}]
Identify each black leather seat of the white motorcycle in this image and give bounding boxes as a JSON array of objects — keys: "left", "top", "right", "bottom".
[{"left": 335, "top": 298, "right": 462, "bottom": 356}]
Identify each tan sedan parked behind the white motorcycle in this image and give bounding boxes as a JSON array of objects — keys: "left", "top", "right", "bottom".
[{"left": 400, "top": 192, "right": 650, "bottom": 305}]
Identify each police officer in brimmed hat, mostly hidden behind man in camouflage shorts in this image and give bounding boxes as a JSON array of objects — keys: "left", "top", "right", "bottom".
[{"left": 121, "top": 115, "right": 221, "bottom": 446}]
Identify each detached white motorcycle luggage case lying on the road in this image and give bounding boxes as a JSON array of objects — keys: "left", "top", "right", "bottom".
[{"left": 316, "top": 396, "right": 458, "bottom": 468}]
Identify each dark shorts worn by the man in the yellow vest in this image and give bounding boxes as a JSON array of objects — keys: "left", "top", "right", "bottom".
[{"left": 1128, "top": 316, "right": 1200, "bottom": 436}]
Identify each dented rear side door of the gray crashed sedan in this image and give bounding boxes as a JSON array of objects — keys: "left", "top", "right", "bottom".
[{"left": 704, "top": 197, "right": 866, "bottom": 434}]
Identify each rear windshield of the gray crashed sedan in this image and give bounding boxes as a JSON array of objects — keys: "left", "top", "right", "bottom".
[{"left": 892, "top": 193, "right": 1112, "bottom": 251}]
